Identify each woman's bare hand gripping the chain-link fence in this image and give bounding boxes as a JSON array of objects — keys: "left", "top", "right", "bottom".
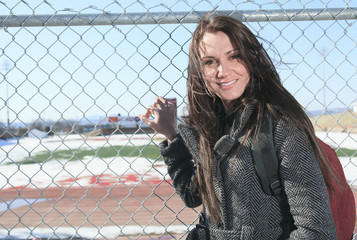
[{"left": 138, "top": 97, "right": 176, "bottom": 143}]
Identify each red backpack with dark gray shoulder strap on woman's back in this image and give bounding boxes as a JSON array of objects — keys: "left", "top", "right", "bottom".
[{"left": 252, "top": 114, "right": 356, "bottom": 240}]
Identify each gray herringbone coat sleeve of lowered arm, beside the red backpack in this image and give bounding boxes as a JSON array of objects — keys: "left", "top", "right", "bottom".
[{"left": 274, "top": 122, "right": 337, "bottom": 240}]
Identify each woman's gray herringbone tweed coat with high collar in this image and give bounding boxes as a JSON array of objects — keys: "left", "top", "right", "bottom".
[{"left": 160, "top": 106, "right": 337, "bottom": 240}]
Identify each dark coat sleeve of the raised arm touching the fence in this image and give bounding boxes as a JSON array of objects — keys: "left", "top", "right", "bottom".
[{"left": 160, "top": 134, "right": 202, "bottom": 208}]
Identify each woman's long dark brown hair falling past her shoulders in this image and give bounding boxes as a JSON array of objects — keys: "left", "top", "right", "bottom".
[{"left": 185, "top": 12, "right": 330, "bottom": 224}]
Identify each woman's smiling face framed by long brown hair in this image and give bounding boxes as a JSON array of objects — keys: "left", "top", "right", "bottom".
[{"left": 200, "top": 31, "right": 250, "bottom": 110}]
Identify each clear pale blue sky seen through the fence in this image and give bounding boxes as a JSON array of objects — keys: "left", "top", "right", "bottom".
[{"left": 0, "top": 0, "right": 357, "bottom": 125}]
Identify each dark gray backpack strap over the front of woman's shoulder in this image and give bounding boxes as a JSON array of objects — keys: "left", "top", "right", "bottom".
[{"left": 252, "top": 112, "right": 281, "bottom": 197}]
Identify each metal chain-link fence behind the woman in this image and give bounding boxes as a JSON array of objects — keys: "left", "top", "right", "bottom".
[{"left": 0, "top": 0, "right": 357, "bottom": 239}]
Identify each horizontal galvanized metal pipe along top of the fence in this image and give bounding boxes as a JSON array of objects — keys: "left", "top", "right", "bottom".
[{"left": 0, "top": 8, "right": 357, "bottom": 28}]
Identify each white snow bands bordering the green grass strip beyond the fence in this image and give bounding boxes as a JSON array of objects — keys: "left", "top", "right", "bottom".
[{"left": 0, "top": 132, "right": 357, "bottom": 189}]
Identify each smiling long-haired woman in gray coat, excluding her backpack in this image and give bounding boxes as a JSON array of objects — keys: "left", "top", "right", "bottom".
[{"left": 139, "top": 15, "right": 336, "bottom": 240}]
